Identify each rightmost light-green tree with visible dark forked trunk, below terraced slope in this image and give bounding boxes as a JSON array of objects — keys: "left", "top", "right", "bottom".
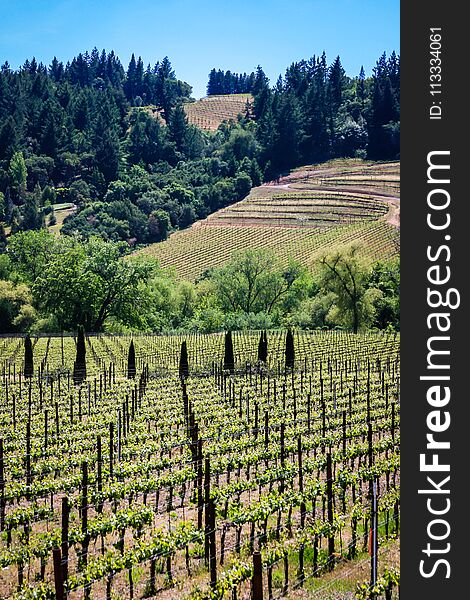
[{"left": 319, "top": 246, "right": 381, "bottom": 333}]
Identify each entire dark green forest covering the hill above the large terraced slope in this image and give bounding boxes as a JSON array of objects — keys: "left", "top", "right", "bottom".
[{"left": 0, "top": 48, "right": 400, "bottom": 244}]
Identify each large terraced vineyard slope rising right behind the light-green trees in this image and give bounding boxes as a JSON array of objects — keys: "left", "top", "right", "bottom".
[{"left": 142, "top": 160, "right": 399, "bottom": 280}]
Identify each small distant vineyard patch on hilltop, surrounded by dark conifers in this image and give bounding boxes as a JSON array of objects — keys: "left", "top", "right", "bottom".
[{"left": 184, "top": 94, "right": 253, "bottom": 131}]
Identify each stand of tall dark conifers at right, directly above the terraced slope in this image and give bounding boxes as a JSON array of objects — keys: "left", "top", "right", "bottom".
[{"left": 253, "top": 52, "right": 400, "bottom": 177}]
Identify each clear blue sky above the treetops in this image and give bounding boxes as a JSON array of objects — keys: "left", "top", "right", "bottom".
[{"left": 0, "top": 0, "right": 400, "bottom": 98}]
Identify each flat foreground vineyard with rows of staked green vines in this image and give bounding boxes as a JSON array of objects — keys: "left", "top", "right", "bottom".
[{"left": 0, "top": 331, "right": 400, "bottom": 600}]
